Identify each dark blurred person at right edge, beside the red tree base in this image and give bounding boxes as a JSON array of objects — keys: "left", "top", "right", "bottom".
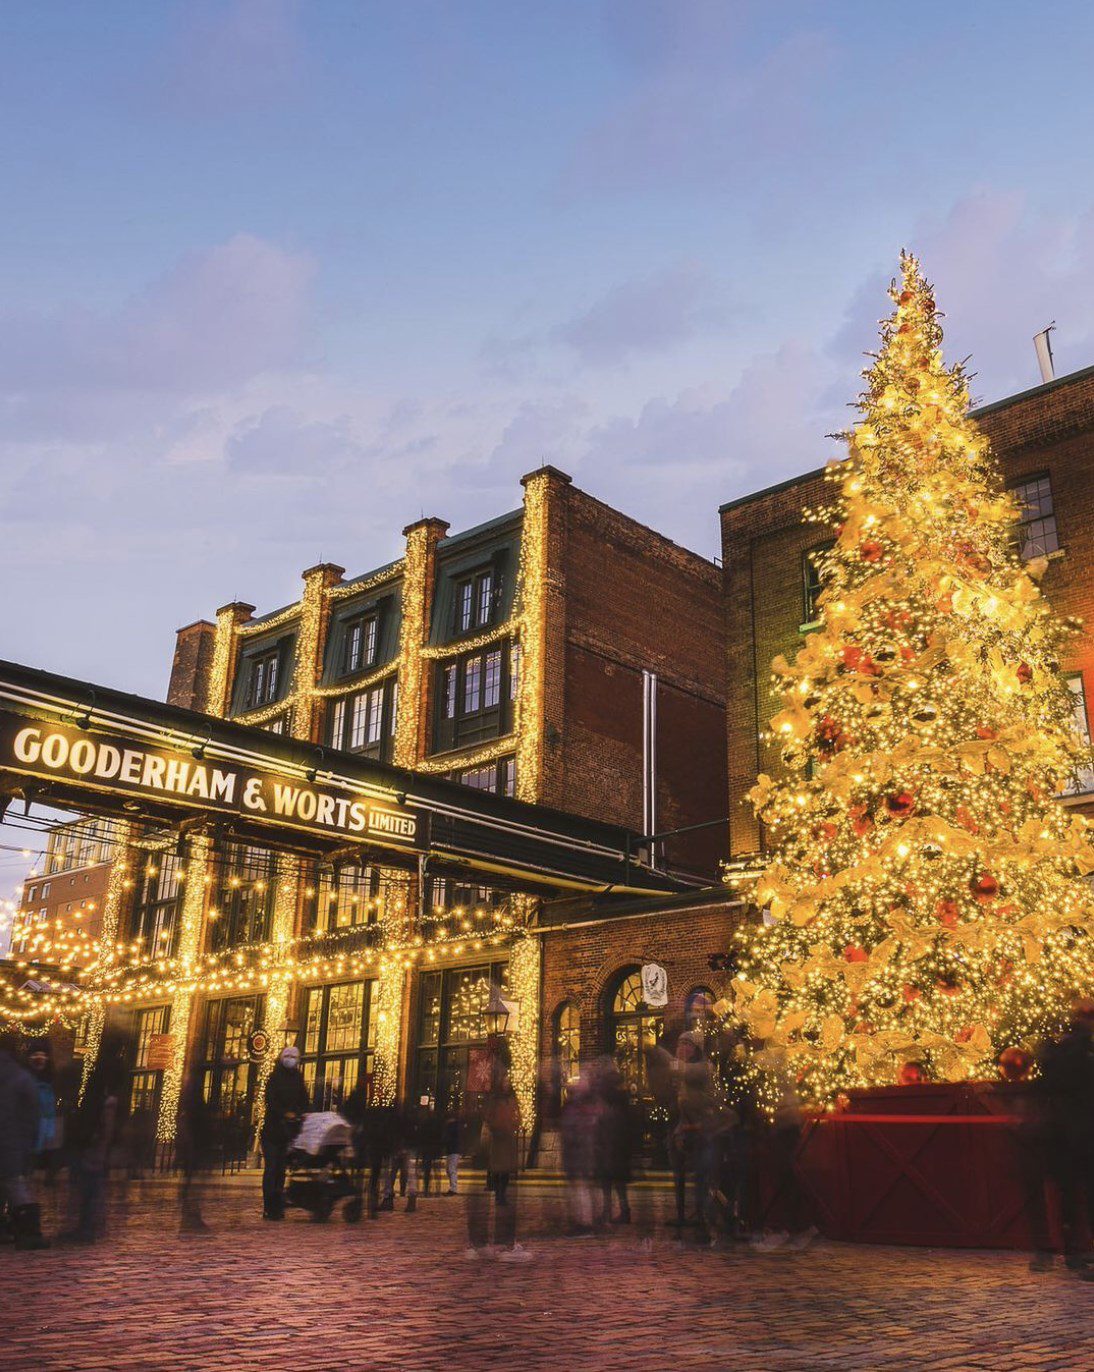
[{"left": 1039, "top": 1000, "right": 1094, "bottom": 1281}]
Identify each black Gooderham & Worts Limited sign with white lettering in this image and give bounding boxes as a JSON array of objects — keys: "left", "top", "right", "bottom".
[{"left": 0, "top": 711, "right": 427, "bottom": 849}]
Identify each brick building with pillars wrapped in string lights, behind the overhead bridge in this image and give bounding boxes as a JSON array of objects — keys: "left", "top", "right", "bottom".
[{"left": 89, "top": 466, "right": 726, "bottom": 1152}]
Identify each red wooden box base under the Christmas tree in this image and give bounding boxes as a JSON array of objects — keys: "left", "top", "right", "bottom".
[{"left": 796, "top": 1083, "right": 1056, "bottom": 1249}]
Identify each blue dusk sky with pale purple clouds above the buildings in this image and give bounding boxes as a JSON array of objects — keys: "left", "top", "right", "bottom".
[{"left": 0, "top": 0, "right": 1094, "bottom": 694}]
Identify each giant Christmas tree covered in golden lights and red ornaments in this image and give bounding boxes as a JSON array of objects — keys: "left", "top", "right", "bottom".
[{"left": 730, "top": 255, "right": 1094, "bottom": 1104}]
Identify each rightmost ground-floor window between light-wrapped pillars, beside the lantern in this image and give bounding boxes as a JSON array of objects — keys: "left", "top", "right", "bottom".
[{"left": 415, "top": 962, "right": 509, "bottom": 1111}]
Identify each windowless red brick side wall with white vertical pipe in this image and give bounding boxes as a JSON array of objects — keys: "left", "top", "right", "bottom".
[{"left": 548, "top": 487, "right": 726, "bottom": 874}]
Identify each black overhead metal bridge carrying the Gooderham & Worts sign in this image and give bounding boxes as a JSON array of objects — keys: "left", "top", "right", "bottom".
[{"left": 0, "top": 661, "right": 686, "bottom": 895}]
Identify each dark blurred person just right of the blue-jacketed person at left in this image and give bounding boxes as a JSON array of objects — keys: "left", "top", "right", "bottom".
[{"left": 60, "top": 1028, "right": 126, "bottom": 1243}]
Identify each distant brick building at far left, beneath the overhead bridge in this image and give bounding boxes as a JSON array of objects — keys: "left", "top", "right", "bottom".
[{"left": 11, "top": 819, "right": 113, "bottom": 966}]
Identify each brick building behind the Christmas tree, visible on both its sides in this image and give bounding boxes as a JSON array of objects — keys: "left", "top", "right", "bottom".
[{"left": 721, "top": 368, "right": 1094, "bottom": 856}]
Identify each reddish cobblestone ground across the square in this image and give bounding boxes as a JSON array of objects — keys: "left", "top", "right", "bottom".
[{"left": 0, "top": 1177, "right": 1094, "bottom": 1372}]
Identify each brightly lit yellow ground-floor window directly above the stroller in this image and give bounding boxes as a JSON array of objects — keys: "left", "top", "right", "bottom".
[{"left": 301, "top": 981, "right": 376, "bottom": 1110}]
